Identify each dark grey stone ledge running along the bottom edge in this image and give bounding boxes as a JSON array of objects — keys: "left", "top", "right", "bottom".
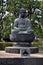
[{"left": 0, "top": 58, "right": 43, "bottom": 65}]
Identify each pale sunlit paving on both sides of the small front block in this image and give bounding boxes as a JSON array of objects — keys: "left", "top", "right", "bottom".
[{"left": 0, "top": 51, "right": 43, "bottom": 58}]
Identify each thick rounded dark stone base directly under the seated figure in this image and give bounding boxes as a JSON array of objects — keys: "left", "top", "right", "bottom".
[{"left": 10, "top": 32, "right": 35, "bottom": 42}]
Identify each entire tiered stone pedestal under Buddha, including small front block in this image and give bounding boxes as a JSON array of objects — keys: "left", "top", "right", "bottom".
[{"left": 5, "top": 32, "right": 38, "bottom": 56}]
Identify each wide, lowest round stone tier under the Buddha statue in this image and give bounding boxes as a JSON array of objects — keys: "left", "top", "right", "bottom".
[{"left": 5, "top": 47, "right": 39, "bottom": 53}]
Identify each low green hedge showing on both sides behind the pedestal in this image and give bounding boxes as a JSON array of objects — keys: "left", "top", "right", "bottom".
[{"left": 0, "top": 42, "right": 42, "bottom": 50}]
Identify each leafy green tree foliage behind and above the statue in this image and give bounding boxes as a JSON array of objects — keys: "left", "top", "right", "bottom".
[{"left": 2, "top": 0, "right": 43, "bottom": 38}]
